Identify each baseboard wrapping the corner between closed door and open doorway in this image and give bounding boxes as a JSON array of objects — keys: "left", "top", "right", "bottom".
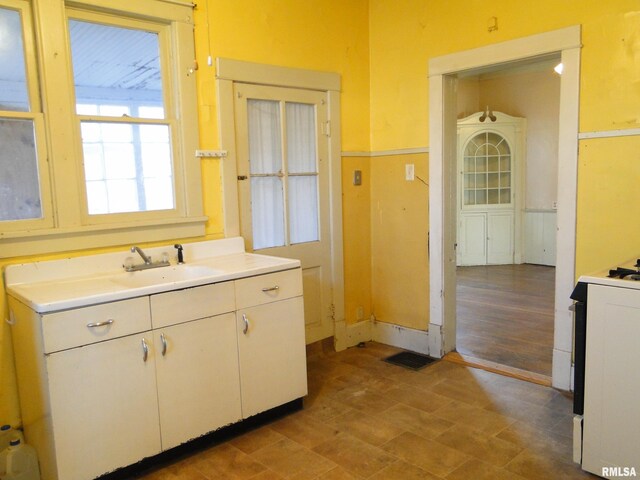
[{"left": 344, "top": 320, "right": 429, "bottom": 355}]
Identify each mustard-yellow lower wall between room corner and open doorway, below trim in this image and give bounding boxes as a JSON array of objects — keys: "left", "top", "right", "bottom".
[{"left": 368, "top": 154, "right": 429, "bottom": 330}]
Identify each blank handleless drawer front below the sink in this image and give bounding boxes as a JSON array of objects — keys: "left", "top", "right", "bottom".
[{"left": 151, "top": 282, "right": 235, "bottom": 328}]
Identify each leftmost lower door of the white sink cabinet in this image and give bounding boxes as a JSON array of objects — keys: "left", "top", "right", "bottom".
[{"left": 46, "top": 332, "right": 160, "bottom": 480}]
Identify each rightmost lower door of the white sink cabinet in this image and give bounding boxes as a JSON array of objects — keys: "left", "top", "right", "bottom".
[{"left": 236, "top": 297, "right": 307, "bottom": 418}]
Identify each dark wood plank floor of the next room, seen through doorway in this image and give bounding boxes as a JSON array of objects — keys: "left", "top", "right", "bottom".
[{"left": 456, "top": 264, "right": 555, "bottom": 376}]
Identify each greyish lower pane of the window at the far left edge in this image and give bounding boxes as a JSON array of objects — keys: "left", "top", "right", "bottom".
[{"left": 0, "top": 118, "right": 42, "bottom": 221}]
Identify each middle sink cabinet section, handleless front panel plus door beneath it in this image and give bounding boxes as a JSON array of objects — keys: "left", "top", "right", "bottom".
[{"left": 151, "top": 282, "right": 242, "bottom": 450}]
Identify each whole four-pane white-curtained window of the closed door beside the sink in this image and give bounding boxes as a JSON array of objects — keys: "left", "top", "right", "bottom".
[{"left": 247, "top": 99, "right": 319, "bottom": 250}]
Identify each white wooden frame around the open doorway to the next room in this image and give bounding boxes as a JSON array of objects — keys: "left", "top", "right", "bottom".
[{"left": 429, "top": 26, "right": 581, "bottom": 390}]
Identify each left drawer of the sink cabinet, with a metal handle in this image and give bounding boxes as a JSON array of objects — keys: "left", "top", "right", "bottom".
[{"left": 42, "top": 297, "right": 151, "bottom": 353}]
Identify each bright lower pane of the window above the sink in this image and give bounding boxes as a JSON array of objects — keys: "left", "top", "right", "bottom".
[{"left": 81, "top": 122, "right": 175, "bottom": 215}]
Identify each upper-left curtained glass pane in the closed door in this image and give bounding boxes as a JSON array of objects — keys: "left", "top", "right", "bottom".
[{"left": 247, "top": 99, "right": 282, "bottom": 174}]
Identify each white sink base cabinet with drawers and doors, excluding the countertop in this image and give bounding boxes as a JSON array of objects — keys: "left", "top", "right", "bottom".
[{"left": 9, "top": 268, "right": 307, "bottom": 480}]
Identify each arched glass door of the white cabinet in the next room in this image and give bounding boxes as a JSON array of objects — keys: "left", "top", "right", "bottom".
[{"left": 462, "top": 131, "right": 512, "bottom": 208}]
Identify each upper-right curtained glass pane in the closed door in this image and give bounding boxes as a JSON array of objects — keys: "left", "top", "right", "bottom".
[{"left": 286, "top": 103, "right": 317, "bottom": 173}]
